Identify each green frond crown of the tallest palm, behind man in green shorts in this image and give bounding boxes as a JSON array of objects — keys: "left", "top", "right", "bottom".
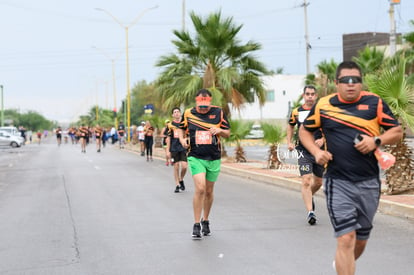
[{"left": 156, "top": 12, "right": 268, "bottom": 116}]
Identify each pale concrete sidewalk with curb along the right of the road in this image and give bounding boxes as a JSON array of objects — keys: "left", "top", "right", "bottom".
[{"left": 126, "top": 144, "right": 414, "bottom": 220}]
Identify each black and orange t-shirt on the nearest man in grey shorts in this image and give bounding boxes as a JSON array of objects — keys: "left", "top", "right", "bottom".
[{"left": 303, "top": 91, "right": 399, "bottom": 182}]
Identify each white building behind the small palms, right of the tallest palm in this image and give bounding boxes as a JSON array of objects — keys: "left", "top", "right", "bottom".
[{"left": 232, "top": 74, "right": 306, "bottom": 123}]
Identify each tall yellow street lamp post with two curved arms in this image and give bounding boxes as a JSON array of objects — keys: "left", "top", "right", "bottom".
[{"left": 96, "top": 5, "right": 158, "bottom": 142}]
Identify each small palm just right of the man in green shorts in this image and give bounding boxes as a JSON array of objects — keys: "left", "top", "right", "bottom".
[{"left": 225, "top": 120, "right": 253, "bottom": 162}]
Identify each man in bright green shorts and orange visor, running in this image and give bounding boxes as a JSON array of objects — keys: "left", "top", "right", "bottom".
[{"left": 179, "top": 89, "right": 230, "bottom": 239}]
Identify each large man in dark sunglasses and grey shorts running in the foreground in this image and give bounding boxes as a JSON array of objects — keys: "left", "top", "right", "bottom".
[{"left": 299, "top": 61, "right": 403, "bottom": 274}]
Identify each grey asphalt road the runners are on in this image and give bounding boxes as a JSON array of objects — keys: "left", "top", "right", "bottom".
[{"left": 0, "top": 138, "right": 414, "bottom": 275}]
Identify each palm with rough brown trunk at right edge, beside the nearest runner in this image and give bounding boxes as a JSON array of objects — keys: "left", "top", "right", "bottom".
[{"left": 365, "top": 57, "right": 414, "bottom": 194}]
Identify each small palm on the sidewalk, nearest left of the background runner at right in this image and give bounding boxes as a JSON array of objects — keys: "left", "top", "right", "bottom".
[{"left": 262, "top": 123, "right": 286, "bottom": 169}]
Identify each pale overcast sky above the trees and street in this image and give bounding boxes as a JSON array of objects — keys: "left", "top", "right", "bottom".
[{"left": 0, "top": 0, "right": 414, "bottom": 121}]
